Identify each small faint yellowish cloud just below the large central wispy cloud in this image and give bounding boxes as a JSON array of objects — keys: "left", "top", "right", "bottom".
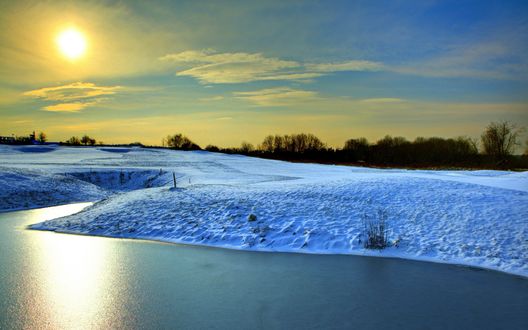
[{"left": 233, "top": 87, "right": 317, "bottom": 107}]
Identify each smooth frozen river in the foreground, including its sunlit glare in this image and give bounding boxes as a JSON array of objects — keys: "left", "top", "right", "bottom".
[{"left": 0, "top": 204, "right": 528, "bottom": 329}]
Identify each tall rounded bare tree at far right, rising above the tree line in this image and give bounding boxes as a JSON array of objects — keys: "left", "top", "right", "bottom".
[{"left": 480, "top": 121, "right": 521, "bottom": 161}]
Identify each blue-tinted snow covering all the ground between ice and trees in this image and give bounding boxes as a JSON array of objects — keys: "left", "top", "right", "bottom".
[{"left": 0, "top": 146, "right": 528, "bottom": 276}]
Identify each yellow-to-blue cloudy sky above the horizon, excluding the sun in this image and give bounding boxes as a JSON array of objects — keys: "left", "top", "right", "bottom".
[{"left": 0, "top": 0, "right": 528, "bottom": 147}]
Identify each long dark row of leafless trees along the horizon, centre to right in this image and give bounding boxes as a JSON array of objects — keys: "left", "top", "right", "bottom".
[{"left": 168, "top": 122, "right": 528, "bottom": 168}]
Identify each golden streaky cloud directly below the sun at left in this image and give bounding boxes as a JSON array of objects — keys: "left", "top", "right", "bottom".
[{"left": 23, "top": 82, "right": 122, "bottom": 112}]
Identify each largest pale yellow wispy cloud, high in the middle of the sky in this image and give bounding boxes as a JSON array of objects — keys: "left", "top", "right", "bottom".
[{"left": 160, "top": 50, "right": 383, "bottom": 84}]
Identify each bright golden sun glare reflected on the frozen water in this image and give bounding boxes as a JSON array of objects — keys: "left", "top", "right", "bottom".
[{"left": 22, "top": 205, "right": 127, "bottom": 329}]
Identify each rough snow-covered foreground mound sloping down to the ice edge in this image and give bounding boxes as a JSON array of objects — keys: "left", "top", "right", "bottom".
[{"left": 31, "top": 178, "right": 528, "bottom": 275}]
